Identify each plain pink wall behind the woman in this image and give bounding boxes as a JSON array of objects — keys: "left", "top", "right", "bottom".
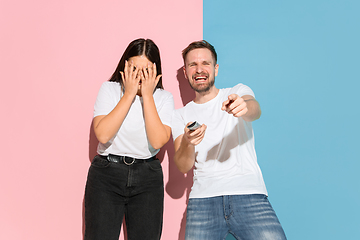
[{"left": 0, "top": 0, "right": 202, "bottom": 240}]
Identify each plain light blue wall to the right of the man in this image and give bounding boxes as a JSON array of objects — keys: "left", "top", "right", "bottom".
[{"left": 203, "top": 0, "right": 360, "bottom": 240}]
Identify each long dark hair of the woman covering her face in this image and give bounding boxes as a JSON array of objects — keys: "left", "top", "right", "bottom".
[{"left": 109, "top": 38, "right": 163, "bottom": 90}]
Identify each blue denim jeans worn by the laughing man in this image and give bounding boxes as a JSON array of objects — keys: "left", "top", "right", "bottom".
[{"left": 185, "top": 194, "right": 286, "bottom": 240}]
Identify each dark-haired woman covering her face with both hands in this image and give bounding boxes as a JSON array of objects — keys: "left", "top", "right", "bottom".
[{"left": 85, "top": 39, "right": 174, "bottom": 240}]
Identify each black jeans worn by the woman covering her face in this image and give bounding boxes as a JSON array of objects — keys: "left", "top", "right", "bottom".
[{"left": 84, "top": 156, "right": 164, "bottom": 240}]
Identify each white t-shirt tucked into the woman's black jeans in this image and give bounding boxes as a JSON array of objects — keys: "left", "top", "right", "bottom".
[{"left": 94, "top": 82, "right": 174, "bottom": 159}]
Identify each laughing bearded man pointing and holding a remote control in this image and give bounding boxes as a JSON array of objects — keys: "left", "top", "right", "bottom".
[{"left": 172, "top": 41, "right": 286, "bottom": 240}]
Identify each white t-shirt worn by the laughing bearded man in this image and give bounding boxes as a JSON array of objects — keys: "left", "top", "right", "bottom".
[{"left": 171, "top": 84, "right": 267, "bottom": 198}]
